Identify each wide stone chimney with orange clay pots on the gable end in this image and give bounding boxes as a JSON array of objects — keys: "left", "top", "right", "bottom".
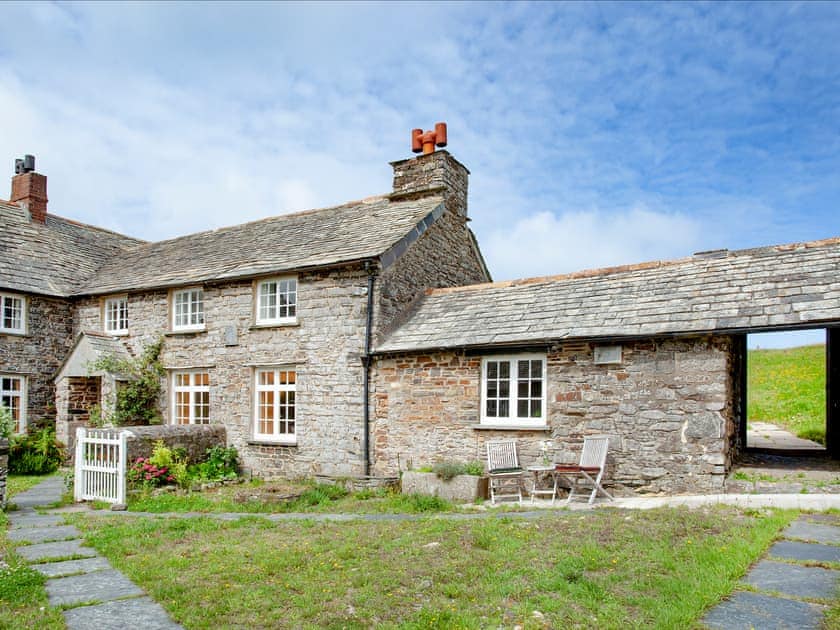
[{"left": 391, "top": 123, "right": 470, "bottom": 217}]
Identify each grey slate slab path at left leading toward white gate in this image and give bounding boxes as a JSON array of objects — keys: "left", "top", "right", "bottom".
[{"left": 7, "top": 477, "right": 181, "bottom": 630}]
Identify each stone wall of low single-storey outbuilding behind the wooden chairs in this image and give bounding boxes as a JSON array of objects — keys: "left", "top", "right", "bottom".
[{"left": 373, "top": 337, "right": 735, "bottom": 492}]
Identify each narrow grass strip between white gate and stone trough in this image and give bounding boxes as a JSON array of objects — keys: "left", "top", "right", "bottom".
[{"left": 122, "top": 482, "right": 454, "bottom": 514}]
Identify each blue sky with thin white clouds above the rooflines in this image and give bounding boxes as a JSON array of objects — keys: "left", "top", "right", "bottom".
[{"left": 0, "top": 2, "right": 840, "bottom": 346}]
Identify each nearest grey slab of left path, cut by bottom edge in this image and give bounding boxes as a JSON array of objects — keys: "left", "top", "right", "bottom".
[{"left": 64, "top": 597, "right": 182, "bottom": 630}]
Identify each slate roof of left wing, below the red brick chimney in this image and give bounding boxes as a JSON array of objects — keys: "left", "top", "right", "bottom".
[{"left": 0, "top": 202, "right": 142, "bottom": 297}]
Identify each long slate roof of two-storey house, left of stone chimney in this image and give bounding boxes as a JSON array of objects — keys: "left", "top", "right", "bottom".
[{"left": 77, "top": 196, "right": 443, "bottom": 295}]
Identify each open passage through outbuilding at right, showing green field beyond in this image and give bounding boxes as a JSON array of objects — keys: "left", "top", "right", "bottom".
[{"left": 734, "top": 328, "right": 840, "bottom": 458}]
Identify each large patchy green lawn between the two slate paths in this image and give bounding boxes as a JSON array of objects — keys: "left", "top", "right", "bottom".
[{"left": 69, "top": 507, "right": 795, "bottom": 628}]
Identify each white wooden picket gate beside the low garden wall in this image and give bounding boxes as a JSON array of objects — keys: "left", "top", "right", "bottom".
[{"left": 74, "top": 427, "right": 128, "bottom": 504}]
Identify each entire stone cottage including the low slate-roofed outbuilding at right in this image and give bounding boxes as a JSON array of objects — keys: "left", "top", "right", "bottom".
[{"left": 0, "top": 139, "right": 840, "bottom": 491}]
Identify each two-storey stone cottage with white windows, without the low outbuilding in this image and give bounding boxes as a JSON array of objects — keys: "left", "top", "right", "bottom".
[{"left": 0, "top": 151, "right": 490, "bottom": 476}]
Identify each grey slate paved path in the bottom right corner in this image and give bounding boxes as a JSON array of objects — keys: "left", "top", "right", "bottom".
[{"left": 703, "top": 514, "right": 840, "bottom": 630}]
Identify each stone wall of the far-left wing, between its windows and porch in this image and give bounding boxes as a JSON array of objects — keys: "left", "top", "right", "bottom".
[{"left": 0, "top": 295, "right": 73, "bottom": 426}]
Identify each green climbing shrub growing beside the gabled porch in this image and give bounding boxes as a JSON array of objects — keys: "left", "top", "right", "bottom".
[{"left": 92, "top": 338, "right": 166, "bottom": 426}]
